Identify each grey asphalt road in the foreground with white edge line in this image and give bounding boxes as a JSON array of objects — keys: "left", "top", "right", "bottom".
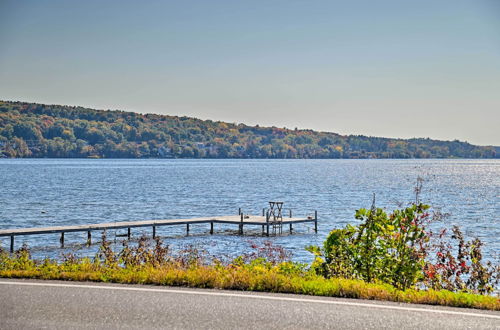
[{"left": 0, "top": 279, "right": 500, "bottom": 330}]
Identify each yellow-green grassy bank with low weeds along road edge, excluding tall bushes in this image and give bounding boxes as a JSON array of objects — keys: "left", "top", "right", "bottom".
[{"left": 0, "top": 246, "right": 500, "bottom": 310}]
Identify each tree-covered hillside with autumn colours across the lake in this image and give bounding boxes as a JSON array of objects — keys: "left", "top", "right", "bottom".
[{"left": 0, "top": 101, "right": 500, "bottom": 158}]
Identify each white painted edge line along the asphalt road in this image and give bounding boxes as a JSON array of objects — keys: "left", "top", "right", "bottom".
[{"left": 0, "top": 281, "right": 500, "bottom": 319}]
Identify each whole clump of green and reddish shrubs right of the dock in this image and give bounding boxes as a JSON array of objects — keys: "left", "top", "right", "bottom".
[{"left": 308, "top": 194, "right": 500, "bottom": 294}]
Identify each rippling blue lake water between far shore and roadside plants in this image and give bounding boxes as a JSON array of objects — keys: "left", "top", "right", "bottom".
[{"left": 0, "top": 159, "right": 500, "bottom": 261}]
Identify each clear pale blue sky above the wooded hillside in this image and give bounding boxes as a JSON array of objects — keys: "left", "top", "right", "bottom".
[{"left": 0, "top": 0, "right": 500, "bottom": 146}]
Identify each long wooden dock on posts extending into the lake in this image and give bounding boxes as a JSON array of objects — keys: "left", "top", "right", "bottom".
[{"left": 0, "top": 209, "right": 318, "bottom": 253}]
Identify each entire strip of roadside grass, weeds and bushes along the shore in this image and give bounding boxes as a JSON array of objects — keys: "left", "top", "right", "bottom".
[{"left": 0, "top": 200, "right": 500, "bottom": 310}]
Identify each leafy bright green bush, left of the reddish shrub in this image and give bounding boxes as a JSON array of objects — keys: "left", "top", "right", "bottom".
[{"left": 308, "top": 203, "right": 430, "bottom": 290}]
